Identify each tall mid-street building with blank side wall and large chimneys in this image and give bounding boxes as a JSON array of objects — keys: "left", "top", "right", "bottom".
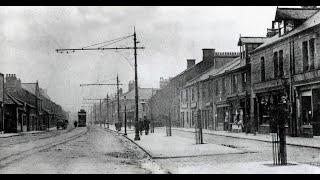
[{"left": 150, "top": 49, "right": 239, "bottom": 126}]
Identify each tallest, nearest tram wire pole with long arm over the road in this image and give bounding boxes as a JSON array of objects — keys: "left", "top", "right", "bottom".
[{"left": 56, "top": 28, "right": 144, "bottom": 140}]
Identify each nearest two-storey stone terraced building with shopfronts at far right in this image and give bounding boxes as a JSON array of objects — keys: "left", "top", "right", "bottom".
[{"left": 251, "top": 6, "right": 320, "bottom": 136}]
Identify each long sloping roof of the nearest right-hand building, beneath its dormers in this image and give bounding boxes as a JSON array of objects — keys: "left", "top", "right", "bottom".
[{"left": 251, "top": 10, "right": 320, "bottom": 53}]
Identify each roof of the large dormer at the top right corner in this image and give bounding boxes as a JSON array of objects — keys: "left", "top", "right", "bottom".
[{"left": 274, "top": 8, "right": 320, "bottom": 21}]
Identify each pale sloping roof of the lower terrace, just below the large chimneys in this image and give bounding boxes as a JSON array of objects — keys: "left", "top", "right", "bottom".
[{"left": 185, "top": 57, "right": 241, "bottom": 86}]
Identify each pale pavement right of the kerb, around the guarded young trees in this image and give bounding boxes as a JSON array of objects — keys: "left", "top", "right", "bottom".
[{"left": 105, "top": 126, "right": 320, "bottom": 174}]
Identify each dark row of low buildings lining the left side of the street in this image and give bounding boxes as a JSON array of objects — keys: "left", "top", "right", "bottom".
[{"left": 4, "top": 74, "right": 66, "bottom": 133}]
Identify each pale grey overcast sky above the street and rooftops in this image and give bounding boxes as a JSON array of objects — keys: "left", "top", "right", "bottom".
[{"left": 0, "top": 6, "right": 276, "bottom": 111}]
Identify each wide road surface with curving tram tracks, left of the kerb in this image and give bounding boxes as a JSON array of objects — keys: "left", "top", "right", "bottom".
[{"left": 0, "top": 127, "right": 151, "bottom": 174}]
